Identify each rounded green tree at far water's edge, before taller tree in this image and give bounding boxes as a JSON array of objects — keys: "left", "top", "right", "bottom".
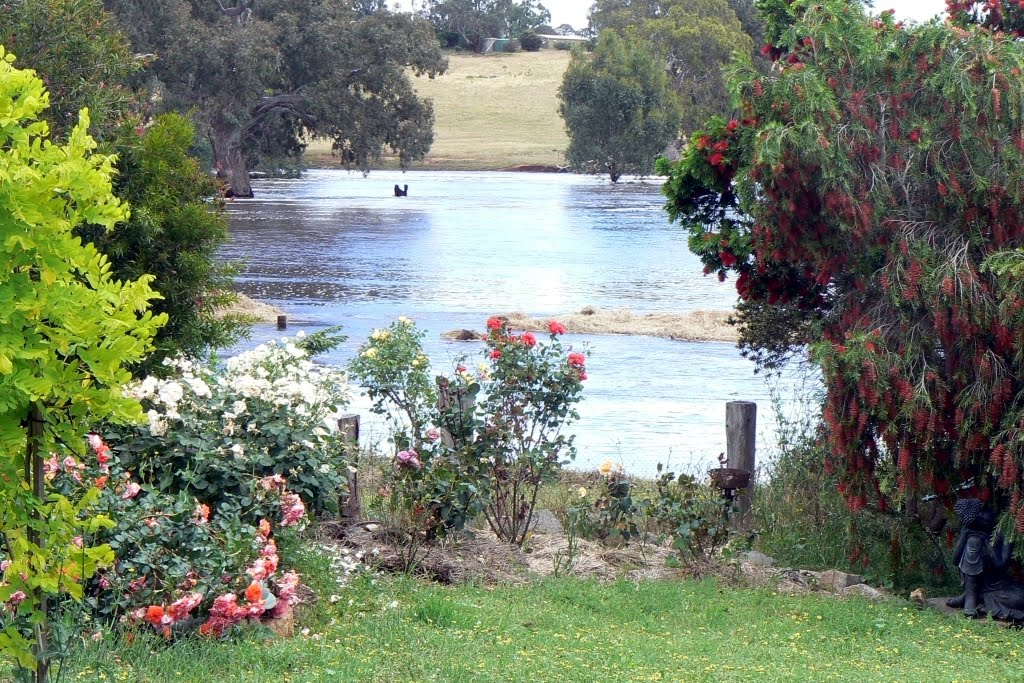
[{"left": 558, "top": 31, "right": 679, "bottom": 182}]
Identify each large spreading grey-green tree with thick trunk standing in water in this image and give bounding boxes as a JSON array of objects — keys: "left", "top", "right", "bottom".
[{"left": 106, "top": 0, "right": 446, "bottom": 197}]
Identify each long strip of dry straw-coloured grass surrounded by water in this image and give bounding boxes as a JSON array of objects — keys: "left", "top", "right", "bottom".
[{"left": 506, "top": 306, "right": 738, "bottom": 342}]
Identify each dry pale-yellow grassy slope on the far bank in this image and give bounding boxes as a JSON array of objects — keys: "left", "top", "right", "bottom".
[{"left": 306, "top": 50, "right": 569, "bottom": 170}]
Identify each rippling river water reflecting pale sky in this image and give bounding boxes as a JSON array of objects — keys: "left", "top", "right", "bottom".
[{"left": 221, "top": 170, "right": 811, "bottom": 474}]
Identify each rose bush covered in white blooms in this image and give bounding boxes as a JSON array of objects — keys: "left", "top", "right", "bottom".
[{"left": 105, "top": 333, "right": 348, "bottom": 521}]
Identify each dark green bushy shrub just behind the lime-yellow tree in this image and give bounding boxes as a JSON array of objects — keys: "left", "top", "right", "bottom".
[{"left": 78, "top": 114, "right": 249, "bottom": 375}]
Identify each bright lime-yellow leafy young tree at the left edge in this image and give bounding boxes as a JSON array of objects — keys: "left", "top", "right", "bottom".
[{"left": 0, "top": 47, "right": 166, "bottom": 678}]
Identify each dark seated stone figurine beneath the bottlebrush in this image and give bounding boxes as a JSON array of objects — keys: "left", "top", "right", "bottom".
[{"left": 946, "top": 498, "right": 1024, "bottom": 622}]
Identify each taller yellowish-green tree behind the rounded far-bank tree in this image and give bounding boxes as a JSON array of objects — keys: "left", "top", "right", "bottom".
[{"left": 591, "top": 0, "right": 760, "bottom": 134}]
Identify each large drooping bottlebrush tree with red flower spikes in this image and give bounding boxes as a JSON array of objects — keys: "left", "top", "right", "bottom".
[{"left": 662, "top": 0, "right": 1024, "bottom": 533}]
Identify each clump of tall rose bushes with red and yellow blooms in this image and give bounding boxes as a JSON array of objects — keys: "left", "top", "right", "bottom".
[{"left": 351, "top": 317, "right": 587, "bottom": 543}]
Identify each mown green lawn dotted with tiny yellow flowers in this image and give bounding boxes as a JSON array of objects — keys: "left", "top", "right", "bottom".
[{"left": 63, "top": 548, "right": 1024, "bottom": 683}]
